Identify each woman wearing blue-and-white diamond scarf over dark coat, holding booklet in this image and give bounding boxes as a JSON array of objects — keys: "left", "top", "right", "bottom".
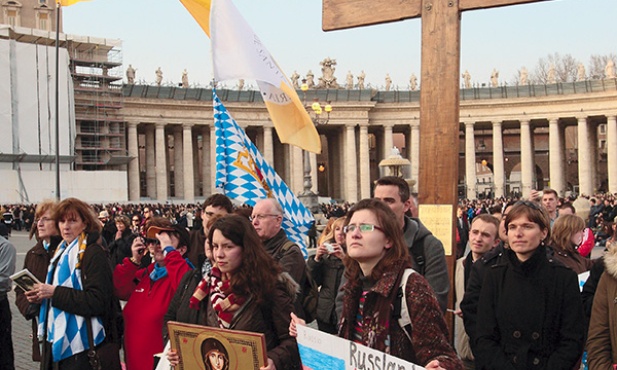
[{"left": 27, "top": 198, "right": 121, "bottom": 370}]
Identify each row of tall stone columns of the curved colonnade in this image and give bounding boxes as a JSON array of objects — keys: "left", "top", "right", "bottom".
[{"left": 127, "top": 115, "right": 617, "bottom": 202}]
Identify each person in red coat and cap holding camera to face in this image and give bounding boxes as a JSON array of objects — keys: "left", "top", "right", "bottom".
[{"left": 114, "top": 217, "right": 192, "bottom": 370}]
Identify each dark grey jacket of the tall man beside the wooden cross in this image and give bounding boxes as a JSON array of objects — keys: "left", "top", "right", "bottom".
[{"left": 403, "top": 217, "right": 450, "bottom": 312}]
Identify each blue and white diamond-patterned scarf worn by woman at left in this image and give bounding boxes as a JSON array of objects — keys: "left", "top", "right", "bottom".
[{"left": 38, "top": 234, "right": 105, "bottom": 362}]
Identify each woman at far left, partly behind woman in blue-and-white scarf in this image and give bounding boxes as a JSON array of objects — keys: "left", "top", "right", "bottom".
[{"left": 15, "top": 201, "right": 62, "bottom": 361}]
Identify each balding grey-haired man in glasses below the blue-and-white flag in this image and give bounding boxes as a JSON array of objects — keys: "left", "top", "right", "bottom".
[{"left": 251, "top": 198, "right": 306, "bottom": 318}]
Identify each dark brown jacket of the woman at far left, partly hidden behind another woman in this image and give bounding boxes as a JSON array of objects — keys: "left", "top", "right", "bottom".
[{"left": 15, "top": 236, "right": 61, "bottom": 362}]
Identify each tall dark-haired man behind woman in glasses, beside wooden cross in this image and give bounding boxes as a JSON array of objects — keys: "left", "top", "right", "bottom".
[{"left": 373, "top": 176, "right": 450, "bottom": 312}]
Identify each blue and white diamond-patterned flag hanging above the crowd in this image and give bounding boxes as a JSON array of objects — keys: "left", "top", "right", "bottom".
[{"left": 213, "top": 92, "right": 315, "bottom": 258}]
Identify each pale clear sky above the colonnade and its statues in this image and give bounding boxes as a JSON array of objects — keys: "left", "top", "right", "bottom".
[{"left": 63, "top": 0, "right": 617, "bottom": 90}]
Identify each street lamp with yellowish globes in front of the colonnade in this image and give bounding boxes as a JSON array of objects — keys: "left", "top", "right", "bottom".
[{"left": 298, "top": 79, "right": 332, "bottom": 213}]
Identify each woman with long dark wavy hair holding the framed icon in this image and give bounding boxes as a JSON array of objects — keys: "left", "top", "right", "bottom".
[{"left": 165, "top": 215, "right": 300, "bottom": 370}]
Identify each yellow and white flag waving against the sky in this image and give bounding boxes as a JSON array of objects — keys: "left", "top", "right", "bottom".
[{"left": 180, "top": 0, "right": 321, "bottom": 153}]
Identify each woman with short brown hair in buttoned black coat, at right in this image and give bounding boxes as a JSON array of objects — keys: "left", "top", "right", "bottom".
[{"left": 475, "top": 202, "right": 584, "bottom": 369}]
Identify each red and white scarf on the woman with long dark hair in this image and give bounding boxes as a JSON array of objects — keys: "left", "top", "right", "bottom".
[{"left": 207, "top": 267, "right": 246, "bottom": 329}]
